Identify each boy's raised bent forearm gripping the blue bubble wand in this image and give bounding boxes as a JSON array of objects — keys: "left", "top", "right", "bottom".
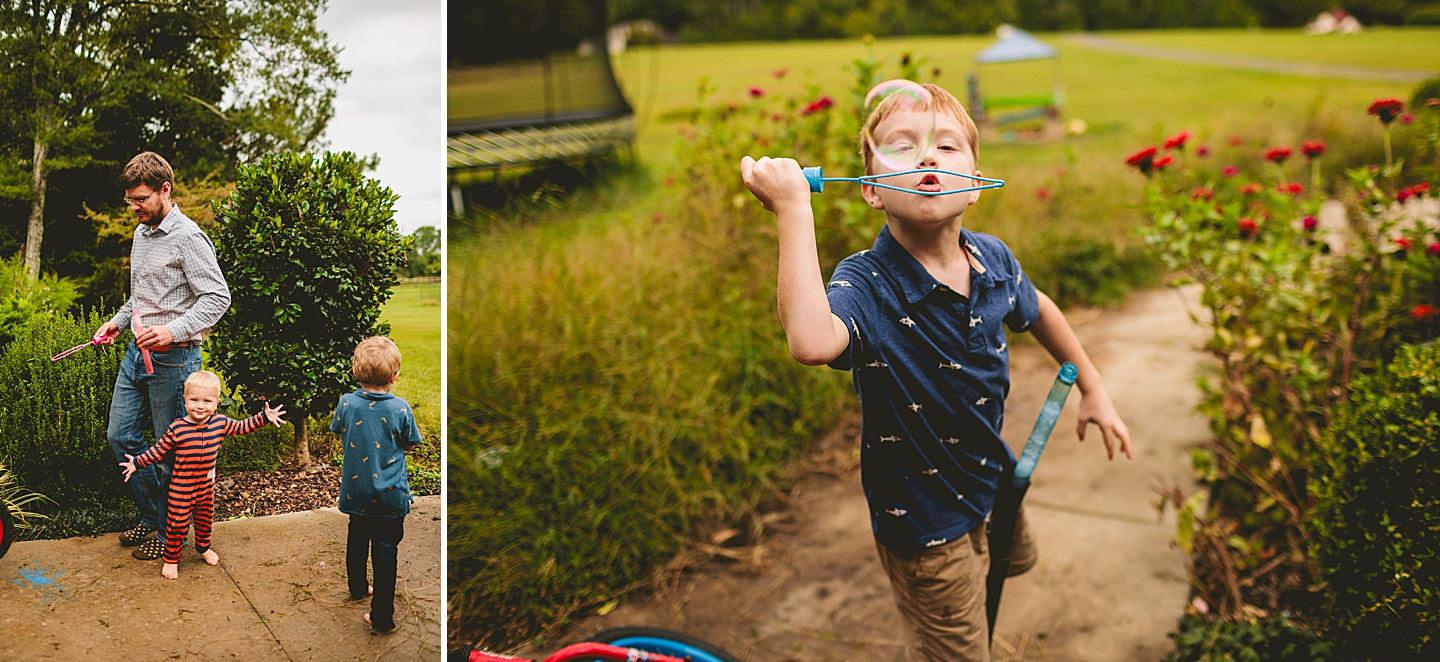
[{"left": 740, "top": 157, "right": 850, "bottom": 366}]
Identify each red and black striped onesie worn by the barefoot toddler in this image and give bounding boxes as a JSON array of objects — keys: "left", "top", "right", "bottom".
[{"left": 135, "top": 412, "right": 265, "bottom": 563}]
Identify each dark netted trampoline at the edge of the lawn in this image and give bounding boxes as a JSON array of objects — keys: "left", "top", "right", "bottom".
[{"left": 446, "top": 3, "right": 635, "bottom": 216}]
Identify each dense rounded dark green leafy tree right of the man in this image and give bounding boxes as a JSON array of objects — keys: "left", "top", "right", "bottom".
[{"left": 210, "top": 153, "right": 410, "bottom": 466}]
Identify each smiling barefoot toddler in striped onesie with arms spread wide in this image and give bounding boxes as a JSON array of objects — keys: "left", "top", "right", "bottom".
[{"left": 120, "top": 370, "right": 285, "bottom": 579}]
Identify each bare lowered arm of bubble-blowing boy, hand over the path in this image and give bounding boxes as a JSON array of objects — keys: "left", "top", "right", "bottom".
[{"left": 1031, "top": 289, "right": 1135, "bottom": 459}]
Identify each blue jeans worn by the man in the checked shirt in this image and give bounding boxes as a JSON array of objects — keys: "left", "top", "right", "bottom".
[{"left": 105, "top": 343, "right": 200, "bottom": 535}]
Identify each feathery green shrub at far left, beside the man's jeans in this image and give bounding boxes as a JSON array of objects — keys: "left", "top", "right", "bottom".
[{"left": 0, "top": 314, "right": 125, "bottom": 508}]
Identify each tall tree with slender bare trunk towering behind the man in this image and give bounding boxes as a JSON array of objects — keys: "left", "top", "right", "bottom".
[{"left": 0, "top": 0, "right": 348, "bottom": 278}]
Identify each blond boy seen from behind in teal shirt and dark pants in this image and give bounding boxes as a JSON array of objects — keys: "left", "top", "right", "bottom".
[{"left": 330, "top": 335, "right": 420, "bottom": 633}]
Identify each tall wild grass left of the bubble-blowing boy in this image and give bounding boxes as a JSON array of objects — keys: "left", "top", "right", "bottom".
[{"left": 448, "top": 173, "right": 845, "bottom": 645}]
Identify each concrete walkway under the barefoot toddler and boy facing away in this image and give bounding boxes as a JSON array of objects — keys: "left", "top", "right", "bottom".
[{"left": 0, "top": 497, "right": 444, "bottom": 661}]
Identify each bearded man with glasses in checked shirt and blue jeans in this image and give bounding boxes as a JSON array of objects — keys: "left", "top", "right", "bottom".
[{"left": 95, "top": 151, "right": 230, "bottom": 561}]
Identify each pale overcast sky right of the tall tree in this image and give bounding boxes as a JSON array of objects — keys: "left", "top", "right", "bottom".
[{"left": 320, "top": 0, "right": 445, "bottom": 233}]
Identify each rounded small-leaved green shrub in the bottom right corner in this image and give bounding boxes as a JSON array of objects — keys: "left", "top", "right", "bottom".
[{"left": 1310, "top": 344, "right": 1440, "bottom": 659}]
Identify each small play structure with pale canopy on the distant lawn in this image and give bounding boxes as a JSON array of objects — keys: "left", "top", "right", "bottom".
[{"left": 966, "top": 26, "right": 1064, "bottom": 142}]
